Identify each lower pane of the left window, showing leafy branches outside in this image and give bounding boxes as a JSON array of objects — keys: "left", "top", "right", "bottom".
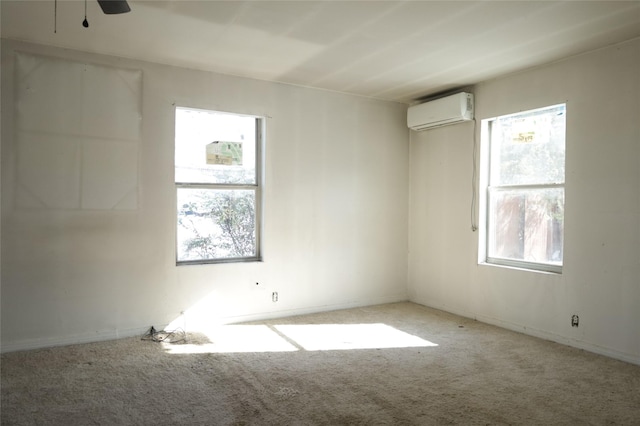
[{"left": 177, "top": 188, "right": 256, "bottom": 262}]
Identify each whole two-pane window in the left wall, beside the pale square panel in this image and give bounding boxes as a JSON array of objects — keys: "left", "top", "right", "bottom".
[{"left": 175, "top": 108, "right": 263, "bottom": 264}]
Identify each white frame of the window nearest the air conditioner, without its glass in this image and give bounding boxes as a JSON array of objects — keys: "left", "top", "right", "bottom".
[{"left": 478, "top": 102, "right": 568, "bottom": 274}]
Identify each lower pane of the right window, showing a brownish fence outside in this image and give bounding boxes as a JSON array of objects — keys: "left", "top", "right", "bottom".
[{"left": 488, "top": 188, "right": 564, "bottom": 265}]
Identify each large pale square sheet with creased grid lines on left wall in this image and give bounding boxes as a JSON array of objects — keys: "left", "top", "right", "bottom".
[{"left": 15, "top": 53, "right": 142, "bottom": 210}]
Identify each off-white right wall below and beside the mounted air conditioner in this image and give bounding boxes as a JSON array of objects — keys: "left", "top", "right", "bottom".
[{"left": 408, "top": 39, "right": 640, "bottom": 364}]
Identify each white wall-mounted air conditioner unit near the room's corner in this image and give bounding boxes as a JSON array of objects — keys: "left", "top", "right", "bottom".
[{"left": 407, "top": 92, "right": 473, "bottom": 131}]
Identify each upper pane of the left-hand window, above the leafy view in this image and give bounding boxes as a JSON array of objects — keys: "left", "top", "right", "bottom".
[{"left": 175, "top": 108, "right": 257, "bottom": 185}]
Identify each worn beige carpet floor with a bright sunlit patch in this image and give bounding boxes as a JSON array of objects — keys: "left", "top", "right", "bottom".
[{"left": 1, "top": 303, "right": 640, "bottom": 425}]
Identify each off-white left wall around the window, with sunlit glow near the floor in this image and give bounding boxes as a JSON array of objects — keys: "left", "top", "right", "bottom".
[{"left": 1, "top": 40, "right": 409, "bottom": 351}]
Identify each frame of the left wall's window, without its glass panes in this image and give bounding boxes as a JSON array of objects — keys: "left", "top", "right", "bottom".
[{"left": 173, "top": 105, "right": 266, "bottom": 266}]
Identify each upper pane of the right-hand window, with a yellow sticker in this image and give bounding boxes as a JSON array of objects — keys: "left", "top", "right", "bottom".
[{"left": 491, "top": 105, "right": 566, "bottom": 186}]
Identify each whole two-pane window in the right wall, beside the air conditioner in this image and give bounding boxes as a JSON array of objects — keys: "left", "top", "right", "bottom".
[{"left": 481, "top": 104, "right": 566, "bottom": 272}]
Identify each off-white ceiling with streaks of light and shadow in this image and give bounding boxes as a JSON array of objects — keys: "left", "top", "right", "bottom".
[{"left": 0, "top": 0, "right": 640, "bottom": 103}]
